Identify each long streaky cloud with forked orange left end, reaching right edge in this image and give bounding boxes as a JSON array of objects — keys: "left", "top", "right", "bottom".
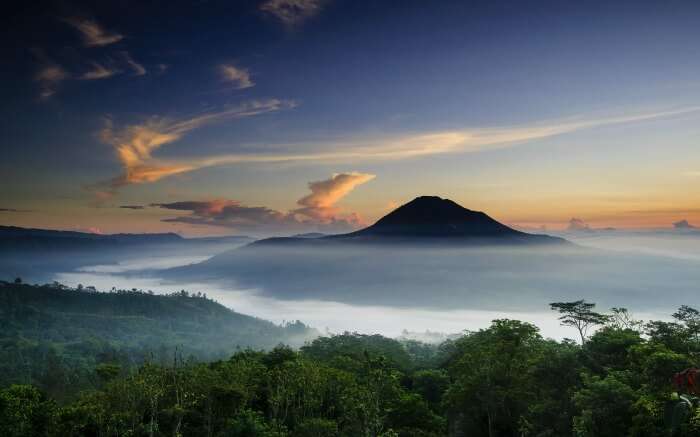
[{"left": 102, "top": 105, "right": 700, "bottom": 191}]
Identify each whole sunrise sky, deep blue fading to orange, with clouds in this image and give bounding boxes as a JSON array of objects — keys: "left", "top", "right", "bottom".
[{"left": 0, "top": 0, "right": 700, "bottom": 236}]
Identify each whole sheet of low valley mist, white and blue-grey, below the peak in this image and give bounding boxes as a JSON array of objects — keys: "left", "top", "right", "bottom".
[{"left": 32, "top": 228, "right": 700, "bottom": 338}]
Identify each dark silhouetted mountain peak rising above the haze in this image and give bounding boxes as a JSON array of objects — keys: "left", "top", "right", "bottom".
[{"left": 252, "top": 196, "right": 567, "bottom": 246}]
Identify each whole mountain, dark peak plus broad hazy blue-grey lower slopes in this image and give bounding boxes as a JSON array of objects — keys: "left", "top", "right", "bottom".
[{"left": 164, "top": 198, "right": 700, "bottom": 314}]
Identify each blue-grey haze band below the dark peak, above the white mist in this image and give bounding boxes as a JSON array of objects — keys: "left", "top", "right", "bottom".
[{"left": 166, "top": 238, "right": 700, "bottom": 311}]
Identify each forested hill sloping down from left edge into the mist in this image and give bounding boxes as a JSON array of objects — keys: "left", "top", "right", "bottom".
[{"left": 0, "top": 281, "right": 315, "bottom": 396}]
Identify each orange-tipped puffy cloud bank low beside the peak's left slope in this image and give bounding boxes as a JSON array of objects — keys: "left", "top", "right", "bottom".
[{"left": 152, "top": 172, "right": 374, "bottom": 233}]
